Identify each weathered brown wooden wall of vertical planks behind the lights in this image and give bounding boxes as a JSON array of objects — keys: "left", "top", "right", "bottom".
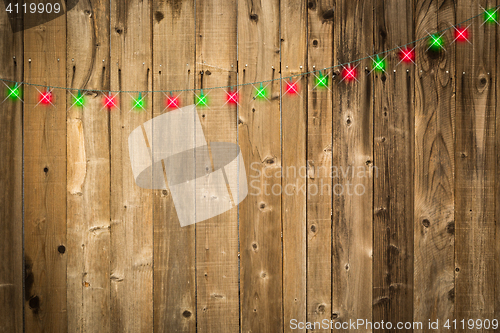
[{"left": 0, "top": 0, "right": 500, "bottom": 333}]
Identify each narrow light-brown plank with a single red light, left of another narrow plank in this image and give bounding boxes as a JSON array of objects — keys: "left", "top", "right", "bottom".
[{"left": 280, "top": 0, "right": 308, "bottom": 332}]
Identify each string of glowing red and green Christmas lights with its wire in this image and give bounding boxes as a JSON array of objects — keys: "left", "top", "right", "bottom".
[{"left": 0, "top": 5, "right": 500, "bottom": 112}]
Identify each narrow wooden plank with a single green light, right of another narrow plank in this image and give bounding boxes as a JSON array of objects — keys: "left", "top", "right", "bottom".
[{"left": 306, "top": 0, "right": 335, "bottom": 332}]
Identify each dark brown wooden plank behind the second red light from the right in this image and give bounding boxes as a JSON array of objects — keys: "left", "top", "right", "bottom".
[{"left": 373, "top": 0, "right": 416, "bottom": 325}]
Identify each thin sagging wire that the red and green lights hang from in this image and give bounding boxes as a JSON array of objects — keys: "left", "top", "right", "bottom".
[{"left": 0, "top": 5, "right": 500, "bottom": 94}]
